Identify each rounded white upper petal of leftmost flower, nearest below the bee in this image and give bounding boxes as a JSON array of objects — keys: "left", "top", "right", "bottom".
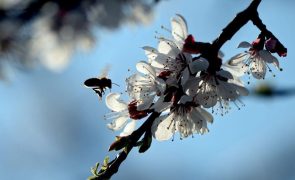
[{"left": 106, "top": 93, "right": 127, "bottom": 112}]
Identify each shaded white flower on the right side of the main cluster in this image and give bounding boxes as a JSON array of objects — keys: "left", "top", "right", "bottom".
[{"left": 183, "top": 62, "right": 249, "bottom": 115}]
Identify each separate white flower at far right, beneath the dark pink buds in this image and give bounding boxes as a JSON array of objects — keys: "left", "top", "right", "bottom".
[{"left": 225, "top": 41, "right": 280, "bottom": 79}]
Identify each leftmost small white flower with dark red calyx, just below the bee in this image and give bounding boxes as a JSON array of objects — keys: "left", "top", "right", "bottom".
[{"left": 105, "top": 93, "right": 147, "bottom": 136}]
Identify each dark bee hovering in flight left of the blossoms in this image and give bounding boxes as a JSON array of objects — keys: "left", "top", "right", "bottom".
[{"left": 84, "top": 65, "right": 114, "bottom": 99}]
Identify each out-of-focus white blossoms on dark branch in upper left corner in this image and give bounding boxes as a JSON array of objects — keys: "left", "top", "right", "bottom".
[{"left": 0, "top": 0, "right": 157, "bottom": 76}]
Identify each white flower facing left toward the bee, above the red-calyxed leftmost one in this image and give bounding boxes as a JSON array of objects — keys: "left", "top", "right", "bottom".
[{"left": 126, "top": 61, "right": 166, "bottom": 110}]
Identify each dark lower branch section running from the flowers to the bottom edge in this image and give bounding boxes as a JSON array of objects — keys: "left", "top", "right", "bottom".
[{"left": 91, "top": 112, "right": 161, "bottom": 180}]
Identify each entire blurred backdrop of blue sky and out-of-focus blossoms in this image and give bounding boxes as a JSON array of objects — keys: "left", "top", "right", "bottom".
[{"left": 0, "top": 0, "right": 295, "bottom": 180}]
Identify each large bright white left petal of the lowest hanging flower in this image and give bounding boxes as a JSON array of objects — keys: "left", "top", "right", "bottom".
[{"left": 151, "top": 114, "right": 175, "bottom": 141}]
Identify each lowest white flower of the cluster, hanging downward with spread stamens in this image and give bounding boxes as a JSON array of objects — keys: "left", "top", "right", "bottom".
[{"left": 151, "top": 96, "right": 213, "bottom": 141}]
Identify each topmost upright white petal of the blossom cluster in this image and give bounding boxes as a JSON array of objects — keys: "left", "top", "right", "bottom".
[{"left": 171, "top": 14, "right": 188, "bottom": 41}]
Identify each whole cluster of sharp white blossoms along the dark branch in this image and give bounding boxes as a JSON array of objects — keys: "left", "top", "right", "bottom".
[{"left": 106, "top": 15, "right": 284, "bottom": 141}]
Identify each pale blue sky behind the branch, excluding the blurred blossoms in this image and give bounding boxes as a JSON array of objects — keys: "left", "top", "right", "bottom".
[{"left": 0, "top": 0, "right": 295, "bottom": 180}]
